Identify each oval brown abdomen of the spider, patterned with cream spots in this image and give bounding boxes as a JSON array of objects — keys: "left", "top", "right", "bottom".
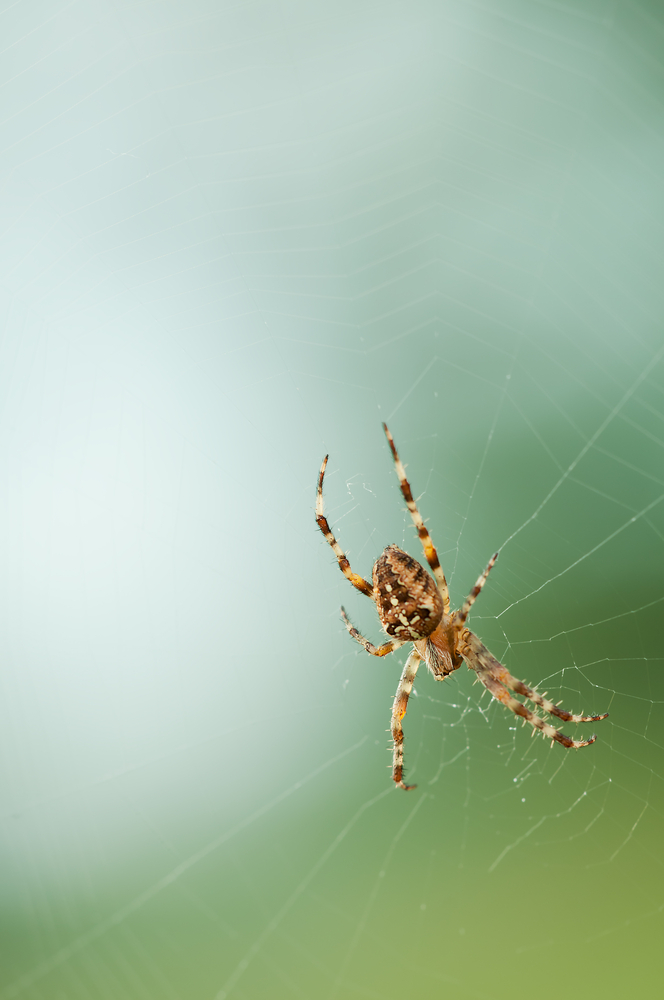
[{"left": 373, "top": 545, "right": 443, "bottom": 642}]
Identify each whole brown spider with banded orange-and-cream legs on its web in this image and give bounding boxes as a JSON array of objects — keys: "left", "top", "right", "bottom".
[{"left": 316, "top": 424, "right": 608, "bottom": 791}]
